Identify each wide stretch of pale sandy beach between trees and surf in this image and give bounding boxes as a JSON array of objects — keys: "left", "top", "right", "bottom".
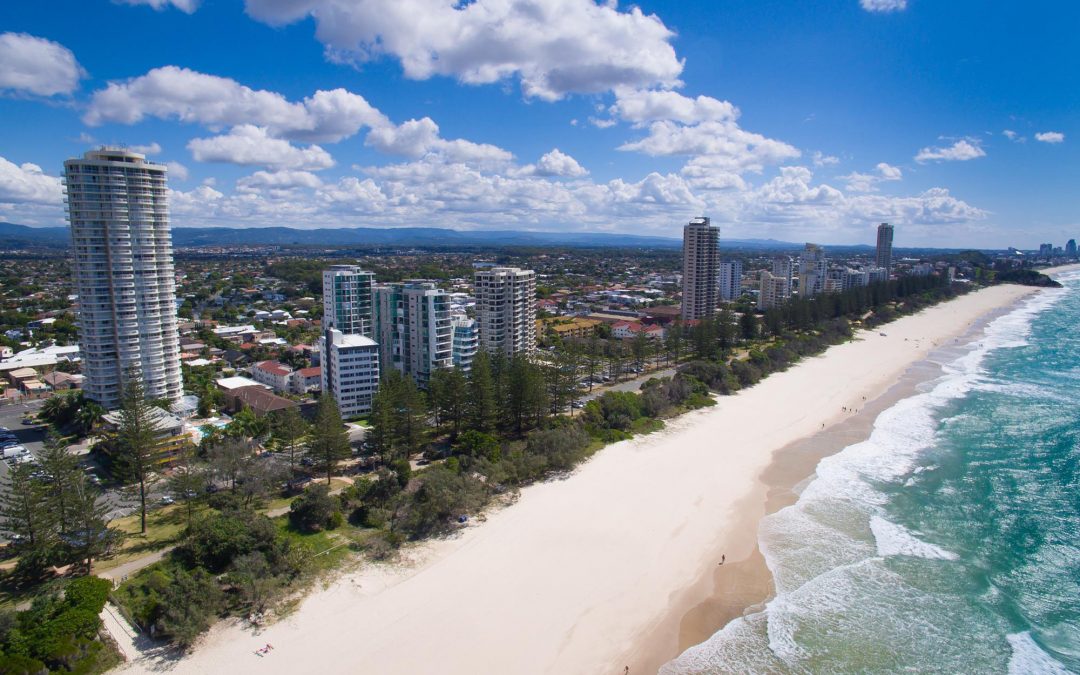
[{"left": 118, "top": 285, "right": 1035, "bottom": 675}]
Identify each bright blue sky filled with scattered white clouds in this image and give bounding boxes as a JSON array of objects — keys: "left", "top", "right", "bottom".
[{"left": 0, "top": 0, "right": 1080, "bottom": 248}]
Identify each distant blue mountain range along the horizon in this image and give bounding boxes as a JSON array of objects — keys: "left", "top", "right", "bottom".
[{"left": 0, "top": 222, "right": 801, "bottom": 251}]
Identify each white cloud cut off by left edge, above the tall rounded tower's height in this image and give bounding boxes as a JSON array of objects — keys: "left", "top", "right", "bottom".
[{"left": 0, "top": 32, "right": 86, "bottom": 96}]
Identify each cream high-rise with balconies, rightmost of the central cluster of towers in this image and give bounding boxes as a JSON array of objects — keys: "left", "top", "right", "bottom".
[{"left": 474, "top": 267, "right": 537, "bottom": 355}]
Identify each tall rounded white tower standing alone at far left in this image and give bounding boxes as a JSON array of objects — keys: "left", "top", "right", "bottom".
[{"left": 64, "top": 148, "right": 184, "bottom": 408}]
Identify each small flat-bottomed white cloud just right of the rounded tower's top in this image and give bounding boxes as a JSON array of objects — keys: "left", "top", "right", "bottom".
[{"left": 188, "top": 124, "right": 334, "bottom": 170}]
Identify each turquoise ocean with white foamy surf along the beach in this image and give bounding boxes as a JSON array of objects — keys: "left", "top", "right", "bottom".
[{"left": 661, "top": 273, "right": 1080, "bottom": 675}]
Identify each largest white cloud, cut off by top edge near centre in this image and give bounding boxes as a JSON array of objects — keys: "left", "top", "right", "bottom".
[{"left": 246, "top": 0, "right": 683, "bottom": 100}]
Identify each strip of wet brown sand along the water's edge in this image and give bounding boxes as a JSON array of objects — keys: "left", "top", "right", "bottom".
[{"left": 626, "top": 291, "right": 1032, "bottom": 673}]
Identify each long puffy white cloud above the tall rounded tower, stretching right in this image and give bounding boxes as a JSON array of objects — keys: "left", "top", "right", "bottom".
[{"left": 83, "top": 66, "right": 389, "bottom": 141}]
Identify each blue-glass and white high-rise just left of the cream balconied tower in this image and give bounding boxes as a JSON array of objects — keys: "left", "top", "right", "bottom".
[{"left": 374, "top": 281, "right": 453, "bottom": 387}]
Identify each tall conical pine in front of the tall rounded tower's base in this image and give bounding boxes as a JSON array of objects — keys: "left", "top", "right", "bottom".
[{"left": 113, "top": 375, "right": 161, "bottom": 534}]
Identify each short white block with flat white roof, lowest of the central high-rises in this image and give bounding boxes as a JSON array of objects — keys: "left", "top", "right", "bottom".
[{"left": 320, "top": 328, "right": 379, "bottom": 418}]
